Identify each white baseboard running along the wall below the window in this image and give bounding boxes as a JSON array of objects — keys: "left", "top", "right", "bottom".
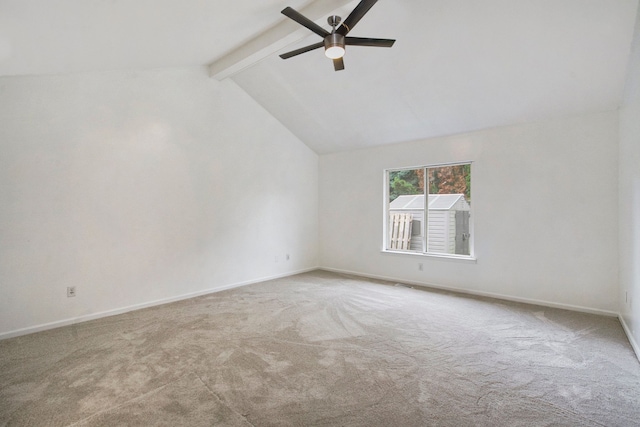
[{"left": 320, "top": 267, "right": 619, "bottom": 317}]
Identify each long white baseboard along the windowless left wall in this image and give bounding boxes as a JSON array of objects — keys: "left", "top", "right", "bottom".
[{"left": 0, "top": 267, "right": 318, "bottom": 340}]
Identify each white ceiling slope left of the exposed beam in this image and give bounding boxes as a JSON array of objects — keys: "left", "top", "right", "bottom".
[{"left": 0, "top": 0, "right": 309, "bottom": 76}]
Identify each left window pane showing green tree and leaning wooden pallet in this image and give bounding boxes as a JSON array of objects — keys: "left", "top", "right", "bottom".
[{"left": 387, "top": 168, "right": 425, "bottom": 251}]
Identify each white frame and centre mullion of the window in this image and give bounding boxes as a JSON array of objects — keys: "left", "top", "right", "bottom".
[{"left": 382, "top": 160, "right": 477, "bottom": 262}]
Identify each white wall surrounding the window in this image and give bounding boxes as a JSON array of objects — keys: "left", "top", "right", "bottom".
[{"left": 320, "top": 111, "right": 620, "bottom": 313}]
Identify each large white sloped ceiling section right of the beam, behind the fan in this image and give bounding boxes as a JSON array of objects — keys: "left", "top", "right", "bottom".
[{"left": 233, "top": 0, "right": 637, "bottom": 153}]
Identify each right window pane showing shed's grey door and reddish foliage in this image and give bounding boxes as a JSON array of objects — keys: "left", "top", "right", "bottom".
[{"left": 427, "top": 164, "right": 471, "bottom": 255}]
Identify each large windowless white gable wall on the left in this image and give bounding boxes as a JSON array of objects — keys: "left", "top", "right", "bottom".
[{"left": 0, "top": 67, "right": 318, "bottom": 338}]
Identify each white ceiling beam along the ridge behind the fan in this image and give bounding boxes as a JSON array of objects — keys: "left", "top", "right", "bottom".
[{"left": 209, "top": 0, "right": 358, "bottom": 80}]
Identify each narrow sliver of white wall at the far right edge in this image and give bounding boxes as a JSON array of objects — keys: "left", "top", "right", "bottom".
[{"left": 620, "top": 5, "right": 640, "bottom": 357}]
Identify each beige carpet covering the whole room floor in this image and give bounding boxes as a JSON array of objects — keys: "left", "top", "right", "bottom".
[{"left": 0, "top": 271, "right": 640, "bottom": 427}]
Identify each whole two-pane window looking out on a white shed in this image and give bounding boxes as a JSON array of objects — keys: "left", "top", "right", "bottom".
[{"left": 385, "top": 163, "right": 473, "bottom": 258}]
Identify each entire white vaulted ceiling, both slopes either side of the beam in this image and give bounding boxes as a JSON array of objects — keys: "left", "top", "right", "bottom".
[{"left": 0, "top": 0, "right": 638, "bottom": 153}]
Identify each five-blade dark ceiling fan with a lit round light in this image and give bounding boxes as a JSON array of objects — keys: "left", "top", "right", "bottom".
[{"left": 280, "top": 0, "right": 395, "bottom": 71}]
